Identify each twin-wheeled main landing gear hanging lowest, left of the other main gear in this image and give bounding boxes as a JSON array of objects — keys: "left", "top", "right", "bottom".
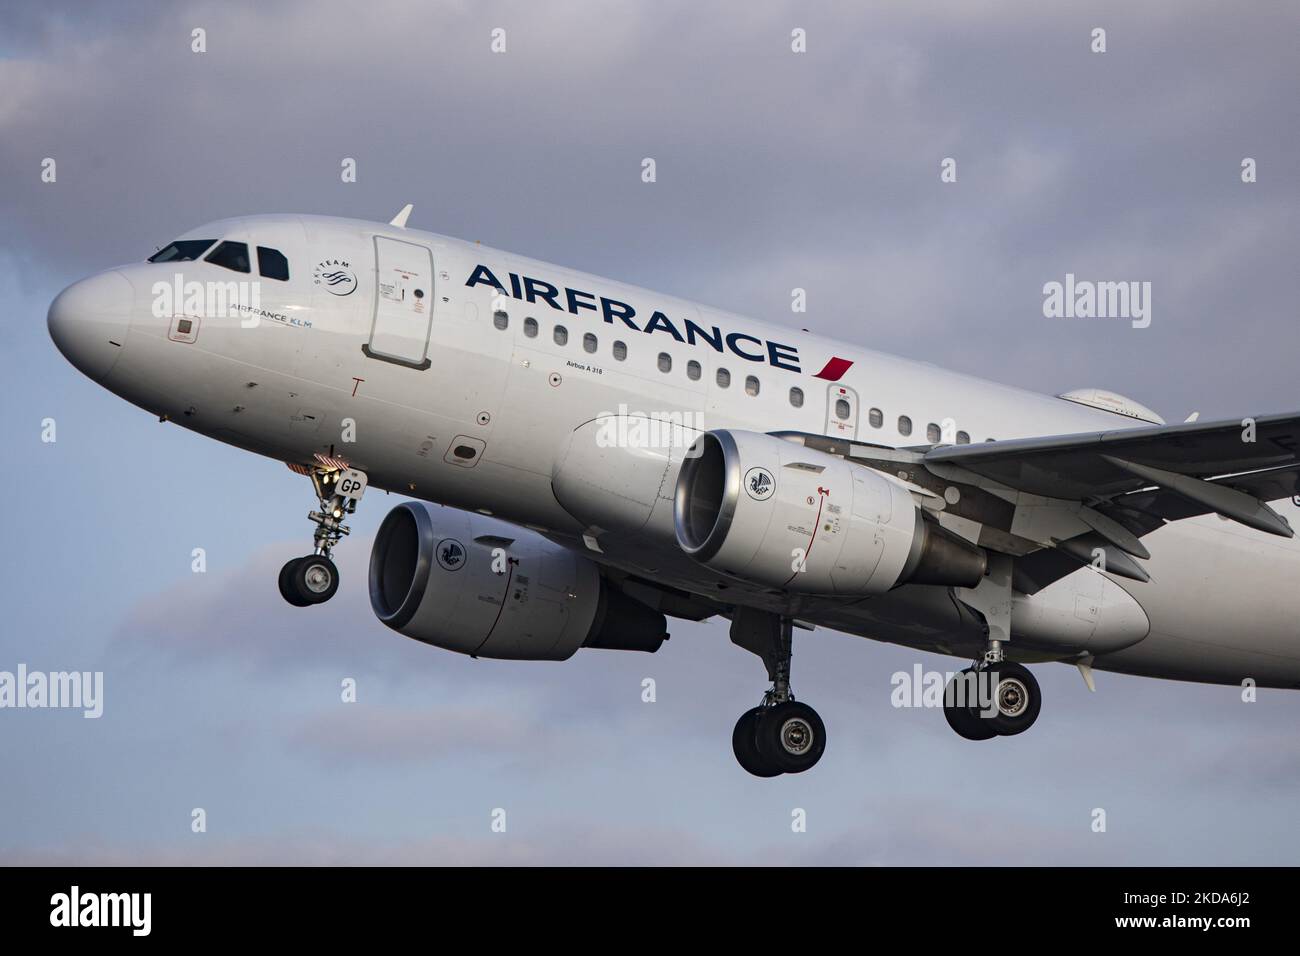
[{"left": 731, "top": 607, "right": 826, "bottom": 777}]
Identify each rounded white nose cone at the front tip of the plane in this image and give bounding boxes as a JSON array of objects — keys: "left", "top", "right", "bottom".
[{"left": 49, "top": 271, "right": 135, "bottom": 381}]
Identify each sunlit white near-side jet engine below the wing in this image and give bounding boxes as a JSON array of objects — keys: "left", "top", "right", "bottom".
[{"left": 673, "top": 431, "right": 988, "bottom": 594}]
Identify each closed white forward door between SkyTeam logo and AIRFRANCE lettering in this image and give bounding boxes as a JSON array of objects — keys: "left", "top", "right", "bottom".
[{"left": 363, "top": 235, "right": 433, "bottom": 369}]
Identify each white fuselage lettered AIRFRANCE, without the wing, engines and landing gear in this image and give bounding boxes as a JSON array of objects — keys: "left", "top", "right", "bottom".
[{"left": 51, "top": 216, "right": 1300, "bottom": 687}]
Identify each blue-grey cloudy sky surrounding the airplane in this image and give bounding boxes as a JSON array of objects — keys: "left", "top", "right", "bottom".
[{"left": 0, "top": 0, "right": 1300, "bottom": 864}]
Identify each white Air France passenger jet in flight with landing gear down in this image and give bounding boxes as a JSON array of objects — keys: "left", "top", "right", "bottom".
[{"left": 48, "top": 206, "right": 1300, "bottom": 778}]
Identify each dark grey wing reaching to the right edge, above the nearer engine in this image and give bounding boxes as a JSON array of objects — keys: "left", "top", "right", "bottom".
[{"left": 787, "top": 414, "right": 1300, "bottom": 593}]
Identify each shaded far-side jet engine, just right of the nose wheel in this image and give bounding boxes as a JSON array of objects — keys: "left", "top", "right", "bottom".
[{"left": 371, "top": 502, "right": 668, "bottom": 661}]
